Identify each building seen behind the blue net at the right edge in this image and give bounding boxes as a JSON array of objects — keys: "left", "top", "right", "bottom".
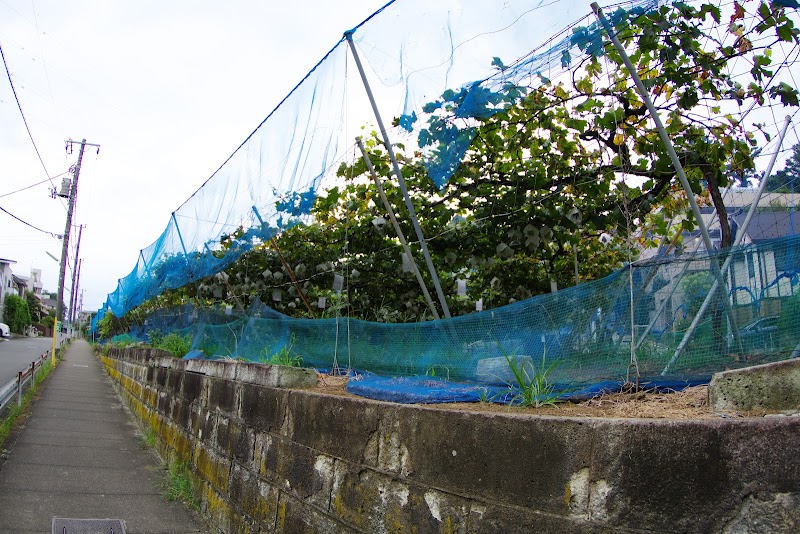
[{"left": 637, "top": 189, "right": 800, "bottom": 331}]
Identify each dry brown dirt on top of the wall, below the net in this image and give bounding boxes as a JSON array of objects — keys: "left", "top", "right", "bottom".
[{"left": 312, "top": 375, "right": 764, "bottom": 419}]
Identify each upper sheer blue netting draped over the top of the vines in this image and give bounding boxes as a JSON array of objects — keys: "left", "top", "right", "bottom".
[{"left": 97, "top": 0, "right": 659, "bottom": 317}]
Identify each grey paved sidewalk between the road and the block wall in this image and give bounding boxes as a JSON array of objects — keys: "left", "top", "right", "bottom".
[{"left": 0, "top": 340, "right": 207, "bottom": 534}]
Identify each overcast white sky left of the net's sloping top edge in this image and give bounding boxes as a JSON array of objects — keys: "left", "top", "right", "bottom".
[{"left": 0, "top": 0, "right": 385, "bottom": 311}]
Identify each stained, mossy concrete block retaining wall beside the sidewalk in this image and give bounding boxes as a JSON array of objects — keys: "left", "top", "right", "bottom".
[{"left": 102, "top": 349, "right": 800, "bottom": 533}]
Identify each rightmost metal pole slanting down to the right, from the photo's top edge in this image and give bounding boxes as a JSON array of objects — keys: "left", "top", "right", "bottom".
[{"left": 591, "top": 2, "right": 741, "bottom": 345}]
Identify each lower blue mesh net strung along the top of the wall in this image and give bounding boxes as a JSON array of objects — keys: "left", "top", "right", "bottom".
[{"left": 109, "top": 234, "right": 800, "bottom": 398}]
